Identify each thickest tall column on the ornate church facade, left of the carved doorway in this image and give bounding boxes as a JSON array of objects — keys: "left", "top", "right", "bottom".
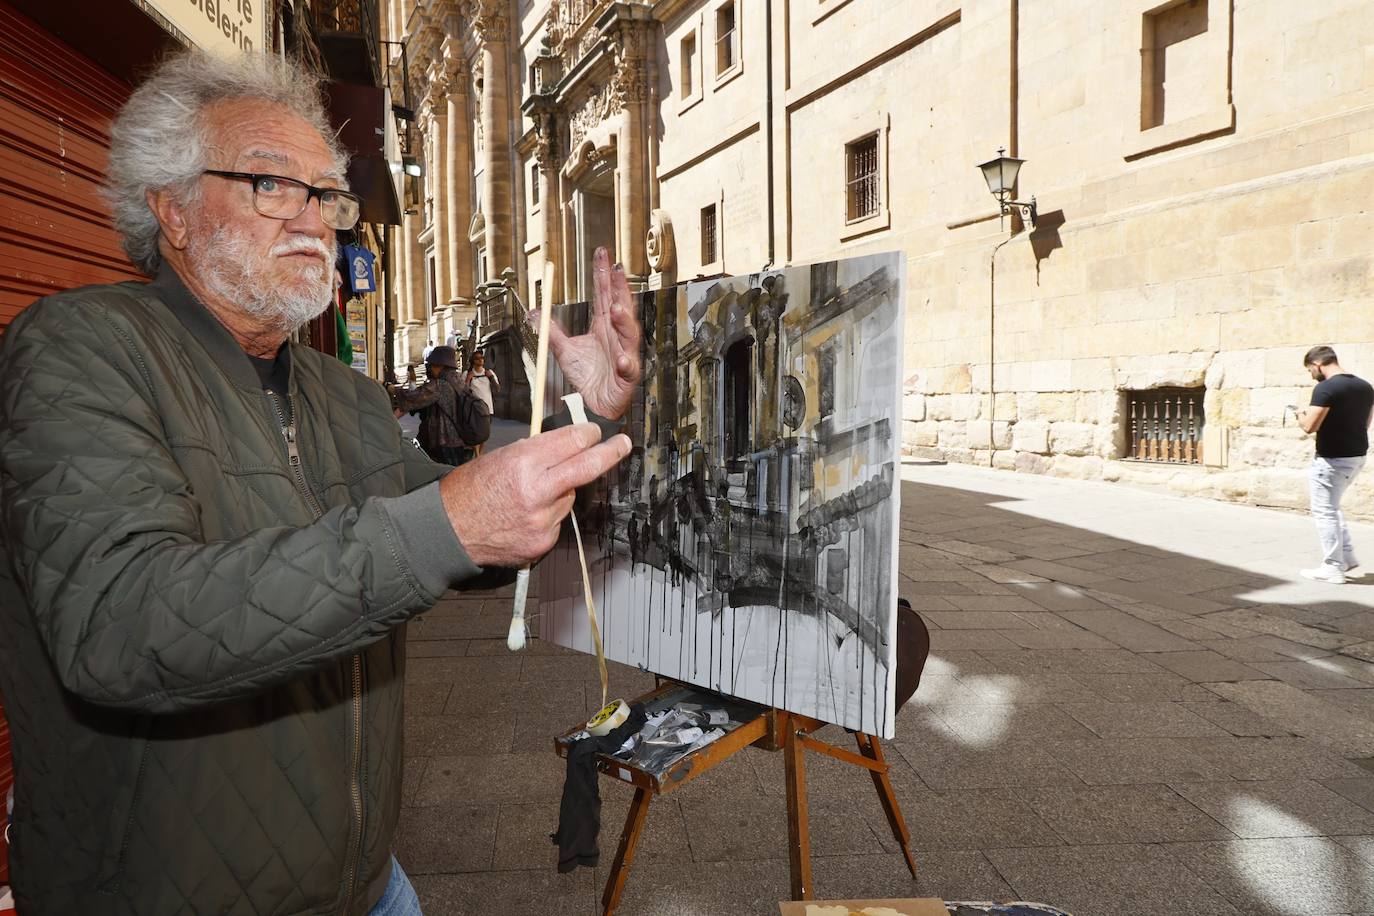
[{"left": 473, "top": 0, "right": 515, "bottom": 280}]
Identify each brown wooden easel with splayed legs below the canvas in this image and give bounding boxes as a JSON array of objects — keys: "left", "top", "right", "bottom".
[{"left": 554, "top": 681, "right": 916, "bottom": 916}]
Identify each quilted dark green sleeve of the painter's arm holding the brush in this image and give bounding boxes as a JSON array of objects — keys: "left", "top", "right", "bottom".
[{"left": 0, "top": 305, "right": 477, "bottom": 713}]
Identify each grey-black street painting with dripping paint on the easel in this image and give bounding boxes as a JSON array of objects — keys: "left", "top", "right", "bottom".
[{"left": 539, "top": 254, "right": 904, "bottom": 737}]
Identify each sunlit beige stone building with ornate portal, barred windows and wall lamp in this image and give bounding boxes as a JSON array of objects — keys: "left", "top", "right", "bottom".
[{"left": 387, "top": 0, "right": 1374, "bottom": 518}]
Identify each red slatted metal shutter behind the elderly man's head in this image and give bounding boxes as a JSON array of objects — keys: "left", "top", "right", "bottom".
[{"left": 0, "top": 0, "right": 140, "bottom": 332}]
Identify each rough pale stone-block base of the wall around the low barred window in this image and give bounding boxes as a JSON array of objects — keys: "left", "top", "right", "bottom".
[{"left": 903, "top": 343, "right": 1374, "bottom": 519}]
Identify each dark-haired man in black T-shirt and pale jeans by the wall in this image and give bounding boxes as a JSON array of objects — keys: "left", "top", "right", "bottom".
[{"left": 1297, "top": 346, "right": 1374, "bottom": 585}]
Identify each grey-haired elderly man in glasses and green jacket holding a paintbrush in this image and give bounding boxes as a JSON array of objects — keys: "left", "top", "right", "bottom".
[{"left": 0, "top": 54, "right": 640, "bottom": 916}]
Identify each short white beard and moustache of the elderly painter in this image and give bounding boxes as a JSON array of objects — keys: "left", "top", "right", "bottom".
[{"left": 187, "top": 225, "right": 335, "bottom": 335}]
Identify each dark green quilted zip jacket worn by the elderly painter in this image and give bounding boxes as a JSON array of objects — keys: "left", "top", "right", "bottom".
[{"left": 0, "top": 269, "right": 478, "bottom": 916}]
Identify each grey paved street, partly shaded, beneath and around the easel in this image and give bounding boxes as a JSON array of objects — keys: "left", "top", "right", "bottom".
[{"left": 397, "top": 466, "right": 1374, "bottom": 916}]
